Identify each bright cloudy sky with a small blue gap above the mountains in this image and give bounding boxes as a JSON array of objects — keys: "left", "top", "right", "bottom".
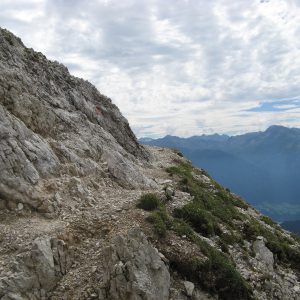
[{"left": 0, "top": 0, "right": 300, "bottom": 137}]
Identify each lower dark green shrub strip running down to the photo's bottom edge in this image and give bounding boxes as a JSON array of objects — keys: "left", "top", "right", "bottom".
[{"left": 147, "top": 206, "right": 253, "bottom": 300}]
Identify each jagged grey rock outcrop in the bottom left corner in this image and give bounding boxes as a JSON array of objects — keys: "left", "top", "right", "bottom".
[{"left": 0, "top": 238, "right": 70, "bottom": 300}]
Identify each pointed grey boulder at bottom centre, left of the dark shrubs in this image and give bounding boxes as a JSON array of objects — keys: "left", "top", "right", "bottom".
[{"left": 100, "top": 229, "right": 170, "bottom": 300}]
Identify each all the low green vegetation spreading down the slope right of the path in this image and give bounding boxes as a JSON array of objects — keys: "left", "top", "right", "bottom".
[{"left": 144, "top": 161, "right": 300, "bottom": 300}]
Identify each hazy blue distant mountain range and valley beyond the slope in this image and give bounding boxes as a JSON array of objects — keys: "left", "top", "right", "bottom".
[{"left": 140, "top": 125, "right": 300, "bottom": 222}]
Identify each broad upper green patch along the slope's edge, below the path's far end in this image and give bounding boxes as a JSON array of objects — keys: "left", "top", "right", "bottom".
[{"left": 167, "top": 162, "right": 248, "bottom": 236}]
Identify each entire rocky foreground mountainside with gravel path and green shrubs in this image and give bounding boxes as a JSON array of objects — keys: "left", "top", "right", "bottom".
[{"left": 0, "top": 29, "right": 300, "bottom": 300}]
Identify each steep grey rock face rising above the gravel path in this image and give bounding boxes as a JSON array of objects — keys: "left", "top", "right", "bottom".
[{"left": 0, "top": 29, "right": 149, "bottom": 211}]
